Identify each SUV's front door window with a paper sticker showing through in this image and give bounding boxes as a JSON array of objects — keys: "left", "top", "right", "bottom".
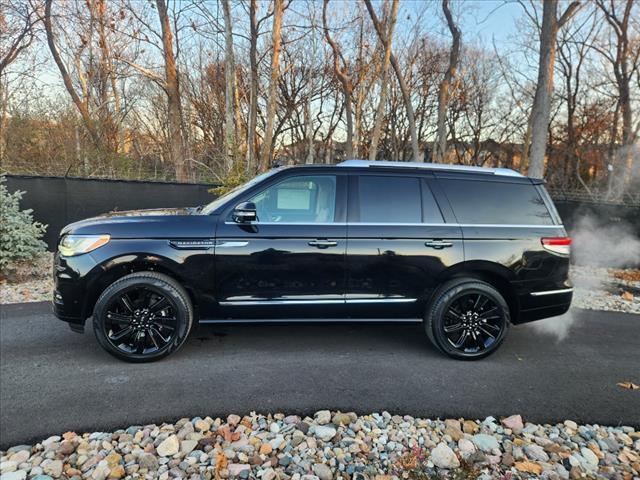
[{"left": 250, "top": 175, "right": 336, "bottom": 223}]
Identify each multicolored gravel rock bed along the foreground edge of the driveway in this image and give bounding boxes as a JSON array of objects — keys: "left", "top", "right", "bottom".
[{"left": 0, "top": 412, "right": 640, "bottom": 480}]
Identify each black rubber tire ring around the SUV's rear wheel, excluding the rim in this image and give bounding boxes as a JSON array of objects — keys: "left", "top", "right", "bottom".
[{"left": 425, "top": 279, "right": 510, "bottom": 360}]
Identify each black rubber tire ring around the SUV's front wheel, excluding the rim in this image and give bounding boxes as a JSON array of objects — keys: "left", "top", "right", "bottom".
[{"left": 93, "top": 274, "right": 193, "bottom": 363}]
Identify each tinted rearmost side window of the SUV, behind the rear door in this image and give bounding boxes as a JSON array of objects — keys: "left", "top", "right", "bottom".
[{"left": 439, "top": 179, "right": 553, "bottom": 225}]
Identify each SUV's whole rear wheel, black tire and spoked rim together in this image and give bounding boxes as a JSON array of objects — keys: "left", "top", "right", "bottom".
[{"left": 424, "top": 278, "right": 511, "bottom": 360}]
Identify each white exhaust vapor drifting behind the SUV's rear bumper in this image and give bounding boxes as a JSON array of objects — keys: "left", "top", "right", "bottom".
[{"left": 531, "top": 214, "right": 640, "bottom": 342}]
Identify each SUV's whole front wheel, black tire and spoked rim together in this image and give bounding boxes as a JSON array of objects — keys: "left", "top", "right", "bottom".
[{"left": 93, "top": 272, "right": 194, "bottom": 363}]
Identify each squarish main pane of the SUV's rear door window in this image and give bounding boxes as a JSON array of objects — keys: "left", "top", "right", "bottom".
[{"left": 357, "top": 175, "right": 422, "bottom": 223}]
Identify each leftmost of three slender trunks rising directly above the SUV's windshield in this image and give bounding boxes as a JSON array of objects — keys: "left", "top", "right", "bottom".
[{"left": 222, "top": 0, "right": 236, "bottom": 172}]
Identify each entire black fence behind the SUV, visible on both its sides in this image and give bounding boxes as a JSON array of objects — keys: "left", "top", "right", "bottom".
[{"left": 7, "top": 175, "right": 640, "bottom": 249}]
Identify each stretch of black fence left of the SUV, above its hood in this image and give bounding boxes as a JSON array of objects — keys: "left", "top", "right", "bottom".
[{"left": 7, "top": 175, "right": 215, "bottom": 250}]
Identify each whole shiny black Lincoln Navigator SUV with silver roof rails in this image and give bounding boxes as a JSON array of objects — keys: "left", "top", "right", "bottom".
[{"left": 53, "top": 160, "right": 573, "bottom": 362}]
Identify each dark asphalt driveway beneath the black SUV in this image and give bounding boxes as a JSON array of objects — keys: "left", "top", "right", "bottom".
[{"left": 0, "top": 303, "right": 640, "bottom": 448}]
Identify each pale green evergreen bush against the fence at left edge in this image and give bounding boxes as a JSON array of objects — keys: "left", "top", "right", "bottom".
[{"left": 0, "top": 177, "right": 47, "bottom": 276}]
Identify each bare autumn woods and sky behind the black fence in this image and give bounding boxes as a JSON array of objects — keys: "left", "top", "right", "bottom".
[{"left": 0, "top": 0, "right": 640, "bottom": 203}]
